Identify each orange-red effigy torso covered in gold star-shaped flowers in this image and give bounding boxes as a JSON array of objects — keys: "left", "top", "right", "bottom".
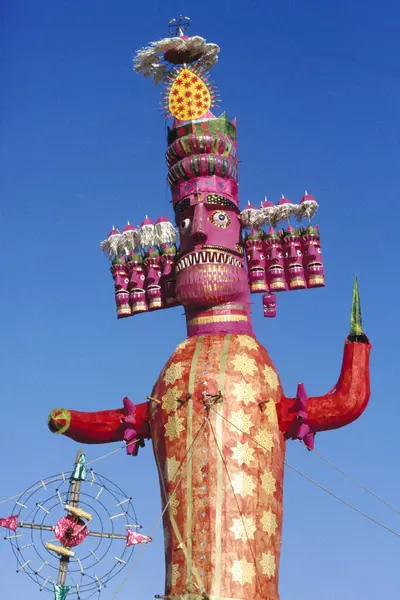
[{"left": 150, "top": 334, "right": 285, "bottom": 600}]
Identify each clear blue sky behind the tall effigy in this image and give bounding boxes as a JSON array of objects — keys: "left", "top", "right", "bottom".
[{"left": 0, "top": 0, "right": 400, "bottom": 600}]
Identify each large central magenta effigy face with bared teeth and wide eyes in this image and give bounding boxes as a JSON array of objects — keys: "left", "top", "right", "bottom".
[{"left": 175, "top": 193, "right": 248, "bottom": 307}]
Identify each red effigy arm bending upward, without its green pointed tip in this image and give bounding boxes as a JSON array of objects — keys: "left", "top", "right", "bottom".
[{"left": 279, "top": 336, "right": 371, "bottom": 439}]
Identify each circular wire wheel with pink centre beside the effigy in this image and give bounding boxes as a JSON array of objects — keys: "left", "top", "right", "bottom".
[{"left": 0, "top": 450, "right": 151, "bottom": 600}]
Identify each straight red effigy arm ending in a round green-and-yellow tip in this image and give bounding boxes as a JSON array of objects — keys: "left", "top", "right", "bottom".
[{"left": 48, "top": 398, "right": 151, "bottom": 456}]
